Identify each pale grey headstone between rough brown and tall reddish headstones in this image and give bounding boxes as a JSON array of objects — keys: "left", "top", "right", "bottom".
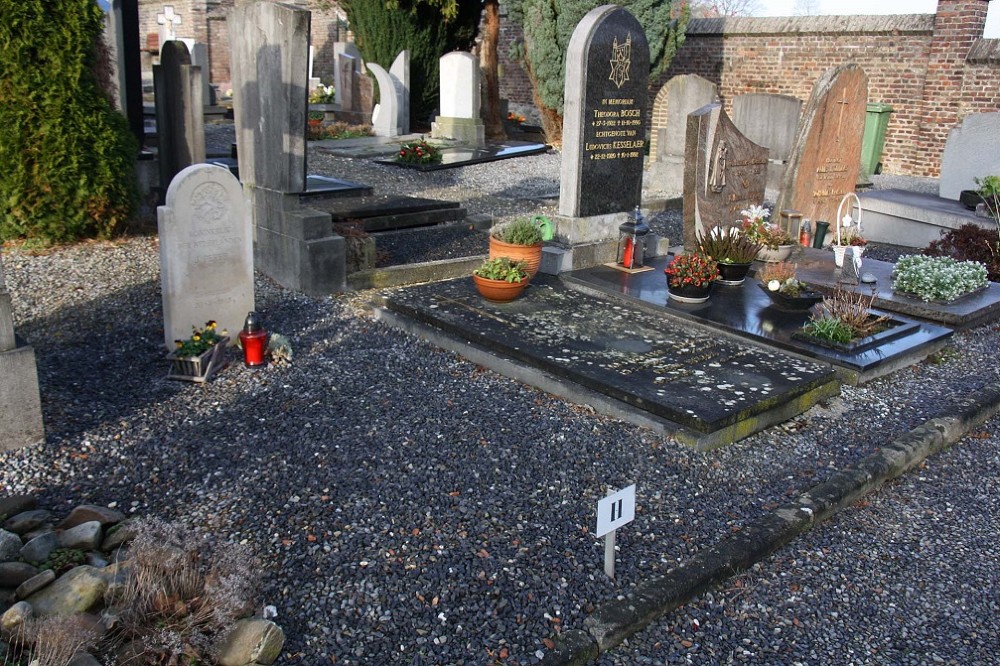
[{"left": 733, "top": 93, "right": 802, "bottom": 189}]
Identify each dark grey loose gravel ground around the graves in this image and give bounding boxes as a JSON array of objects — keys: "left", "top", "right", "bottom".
[{"left": 0, "top": 131, "right": 1000, "bottom": 665}]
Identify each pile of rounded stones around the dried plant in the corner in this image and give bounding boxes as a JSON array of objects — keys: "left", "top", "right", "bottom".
[{"left": 0, "top": 495, "right": 285, "bottom": 666}]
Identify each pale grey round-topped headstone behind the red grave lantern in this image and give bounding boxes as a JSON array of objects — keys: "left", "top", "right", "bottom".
[{"left": 156, "top": 164, "right": 254, "bottom": 349}]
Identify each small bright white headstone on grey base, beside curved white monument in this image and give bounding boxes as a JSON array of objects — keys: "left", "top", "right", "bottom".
[{"left": 431, "top": 51, "right": 486, "bottom": 145}]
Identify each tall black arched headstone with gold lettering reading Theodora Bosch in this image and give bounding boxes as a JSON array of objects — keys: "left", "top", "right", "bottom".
[{"left": 556, "top": 5, "right": 649, "bottom": 223}]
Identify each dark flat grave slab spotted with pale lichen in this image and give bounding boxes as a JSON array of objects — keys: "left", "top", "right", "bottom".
[{"left": 383, "top": 275, "right": 839, "bottom": 449}]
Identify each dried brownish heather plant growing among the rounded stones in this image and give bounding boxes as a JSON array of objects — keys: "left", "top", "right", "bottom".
[{"left": 105, "top": 519, "right": 259, "bottom": 664}]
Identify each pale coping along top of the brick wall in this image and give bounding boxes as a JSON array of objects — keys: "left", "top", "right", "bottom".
[{"left": 686, "top": 14, "right": 934, "bottom": 36}]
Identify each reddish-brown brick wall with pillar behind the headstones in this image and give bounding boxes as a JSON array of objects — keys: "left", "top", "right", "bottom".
[{"left": 501, "top": 0, "right": 1000, "bottom": 176}]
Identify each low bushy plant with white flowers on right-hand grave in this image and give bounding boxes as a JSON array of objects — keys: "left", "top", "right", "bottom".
[{"left": 892, "top": 254, "right": 987, "bottom": 301}]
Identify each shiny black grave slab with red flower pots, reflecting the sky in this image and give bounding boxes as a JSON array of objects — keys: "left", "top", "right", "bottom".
[{"left": 562, "top": 250, "right": 952, "bottom": 383}]
